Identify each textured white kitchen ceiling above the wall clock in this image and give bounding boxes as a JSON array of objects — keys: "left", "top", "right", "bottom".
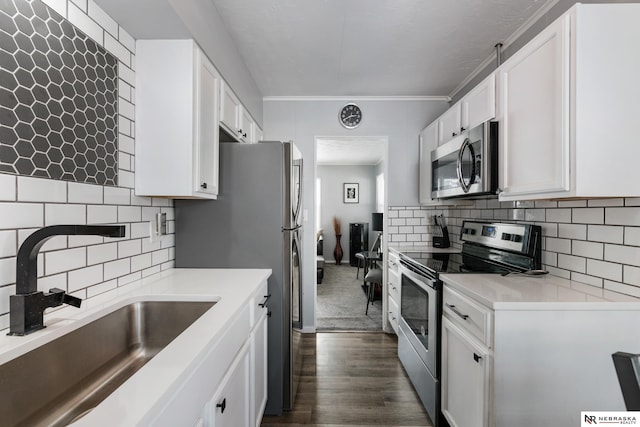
[{"left": 211, "top": 0, "right": 550, "bottom": 96}]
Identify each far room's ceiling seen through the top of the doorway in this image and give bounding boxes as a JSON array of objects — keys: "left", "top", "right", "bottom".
[{"left": 316, "top": 137, "right": 387, "bottom": 165}]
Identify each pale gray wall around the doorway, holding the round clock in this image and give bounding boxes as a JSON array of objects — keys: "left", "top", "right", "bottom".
[{"left": 263, "top": 99, "right": 448, "bottom": 328}]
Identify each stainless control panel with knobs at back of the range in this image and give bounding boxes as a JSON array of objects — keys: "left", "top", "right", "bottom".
[{"left": 460, "top": 221, "right": 531, "bottom": 253}]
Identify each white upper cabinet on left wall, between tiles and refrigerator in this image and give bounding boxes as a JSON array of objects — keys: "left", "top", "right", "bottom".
[{"left": 135, "top": 40, "right": 221, "bottom": 199}]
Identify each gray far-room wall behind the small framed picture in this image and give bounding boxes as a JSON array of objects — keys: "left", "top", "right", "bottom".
[{"left": 317, "top": 165, "right": 377, "bottom": 264}]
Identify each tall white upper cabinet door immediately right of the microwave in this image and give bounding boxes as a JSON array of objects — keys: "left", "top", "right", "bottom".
[{"left": 498, "top": 16, "right": 570, "bottom": 200}]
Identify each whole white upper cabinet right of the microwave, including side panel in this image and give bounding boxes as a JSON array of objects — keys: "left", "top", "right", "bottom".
[{"left": 497, "top": 4, "right": 640, "bottom": 200}]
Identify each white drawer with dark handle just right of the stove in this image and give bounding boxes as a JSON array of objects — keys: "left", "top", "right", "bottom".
[{"left": 442, "top": 286, "right": 493, "bottom": 348}]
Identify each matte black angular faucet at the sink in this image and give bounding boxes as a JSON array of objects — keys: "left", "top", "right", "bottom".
[{"left": 8, "top": 225, "right": 125, "bottom": 336}]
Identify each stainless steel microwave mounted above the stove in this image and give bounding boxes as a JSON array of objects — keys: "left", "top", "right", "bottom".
[{"left": 431, "top": 122, "right": 498, "bottom": 199}]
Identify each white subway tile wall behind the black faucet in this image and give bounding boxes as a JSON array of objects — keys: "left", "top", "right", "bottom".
[{"left": 0, "top": 0, "right": 175, "bottom": 333}]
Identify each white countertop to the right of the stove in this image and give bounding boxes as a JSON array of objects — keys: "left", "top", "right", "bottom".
[{"left": 440, "top": 273, "right": 640, "bottom": 310}]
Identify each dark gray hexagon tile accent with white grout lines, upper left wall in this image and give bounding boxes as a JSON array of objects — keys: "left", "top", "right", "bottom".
[{"left": 0, "top": 0, "right": 118, "bottom": 185}]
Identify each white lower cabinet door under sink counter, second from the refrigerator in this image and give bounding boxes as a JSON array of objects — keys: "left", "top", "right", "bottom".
[{"left": 211, "top": 345, "right": 251, "bottom": 427}]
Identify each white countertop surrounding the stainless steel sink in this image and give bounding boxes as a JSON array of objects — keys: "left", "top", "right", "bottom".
[{"left": 0, "top": 269, "right": 271, "bottom": 426}]
